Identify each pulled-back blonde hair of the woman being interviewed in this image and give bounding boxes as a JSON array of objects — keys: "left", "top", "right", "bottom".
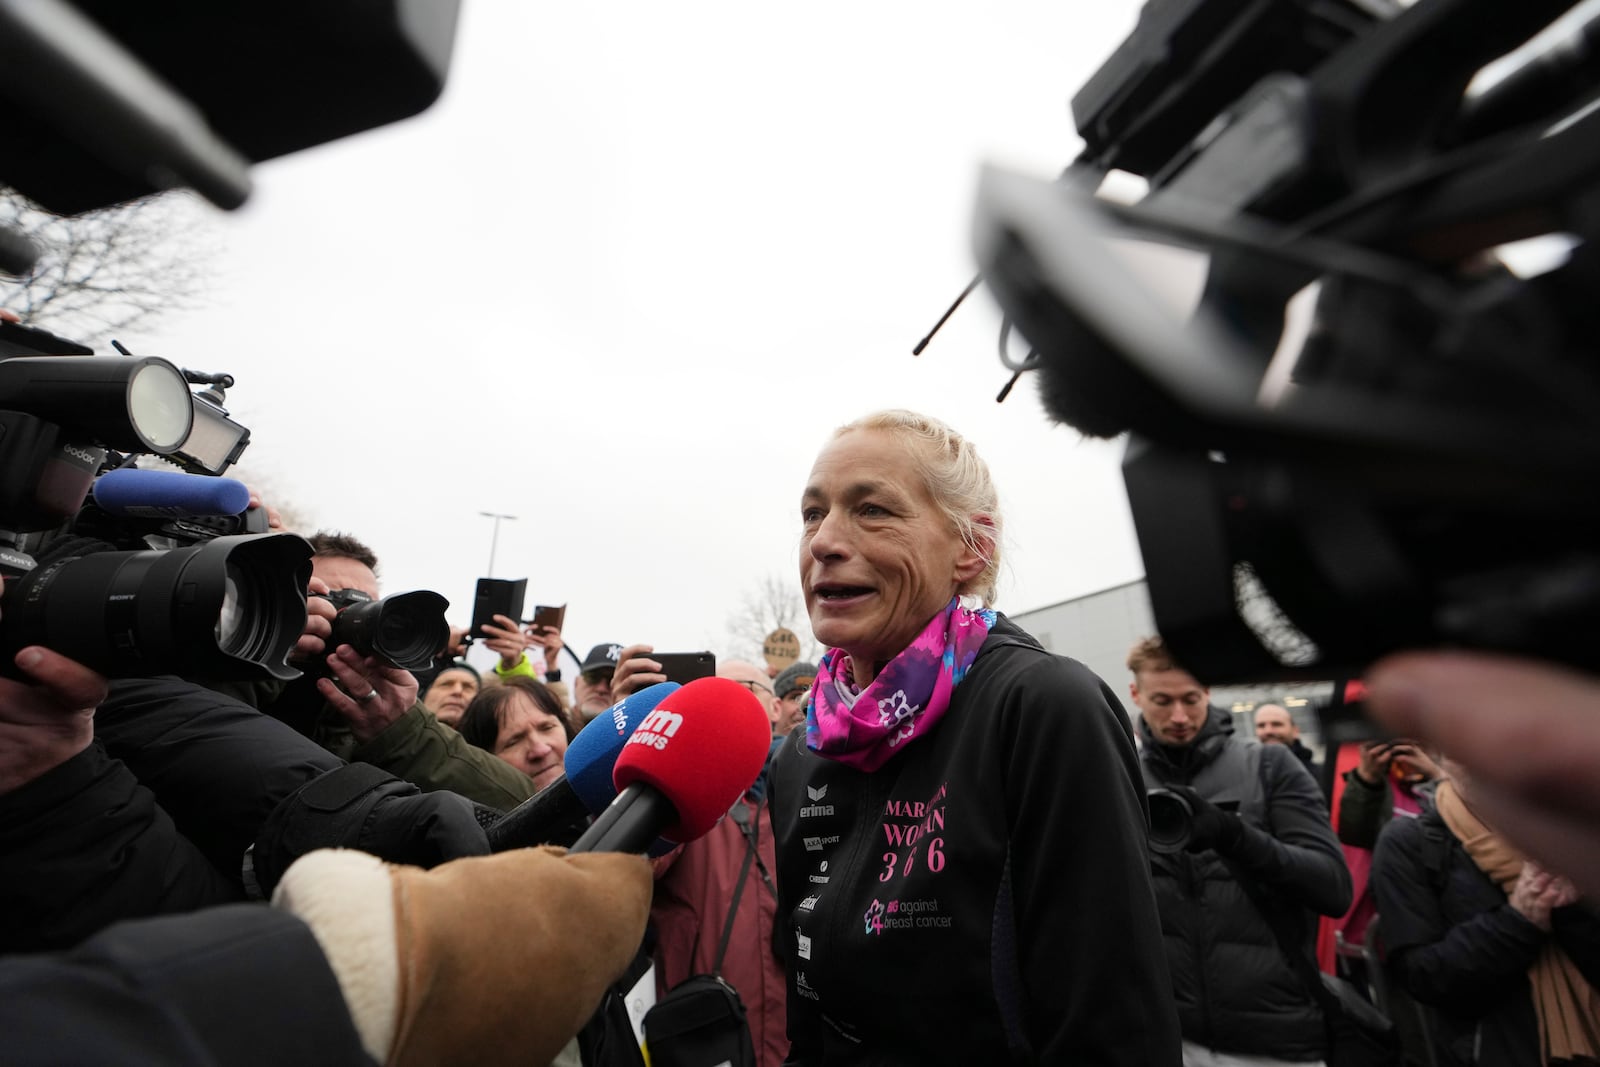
[{"left": 834, "top": 410, "right": 1000, "bottom": 608}]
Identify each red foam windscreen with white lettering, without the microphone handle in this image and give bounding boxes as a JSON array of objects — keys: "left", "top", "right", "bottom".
[{"left": 614, "top": 678, "right": 773, "bottom": 841}]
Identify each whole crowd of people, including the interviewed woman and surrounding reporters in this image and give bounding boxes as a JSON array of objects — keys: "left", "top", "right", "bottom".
[{"left": 0, "top": 404, "right": 1600, "bottom": 1067}]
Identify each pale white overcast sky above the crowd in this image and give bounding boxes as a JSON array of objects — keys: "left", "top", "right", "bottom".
[{"left": 140, "top": 0, "right": 1142, "bottom": 668}]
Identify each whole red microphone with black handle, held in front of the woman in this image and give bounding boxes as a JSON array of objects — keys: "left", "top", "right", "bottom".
[{"left": 568, "top": 678, "right": 773, "bottom": 853}]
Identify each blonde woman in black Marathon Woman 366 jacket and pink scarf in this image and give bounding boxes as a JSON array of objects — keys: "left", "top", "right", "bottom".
[{"left": 771, "top": 411, "right": 1179, "bottom": 1067}]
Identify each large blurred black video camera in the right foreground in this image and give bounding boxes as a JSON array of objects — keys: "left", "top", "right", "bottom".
[{"left": 973, "top": 0, "right": 1600, "bottom": 683}]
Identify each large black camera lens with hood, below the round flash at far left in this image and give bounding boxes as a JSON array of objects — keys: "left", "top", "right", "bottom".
[{"left": 0, "top": 533, "right": 310, "bottom": 681}]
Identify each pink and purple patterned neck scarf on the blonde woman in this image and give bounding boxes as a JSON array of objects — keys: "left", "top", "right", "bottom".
[{"left": 805, "top": 597, "right": 995, "bottom": 771}]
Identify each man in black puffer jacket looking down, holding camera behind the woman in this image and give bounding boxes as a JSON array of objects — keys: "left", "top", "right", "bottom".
[{"left": 1128, "top": 637, "right": 1350, "bottom": 1067}]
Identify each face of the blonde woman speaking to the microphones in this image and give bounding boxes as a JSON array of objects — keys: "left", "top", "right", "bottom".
[{"left": 800, "top": 430, "right": 984, "bottom": 685}]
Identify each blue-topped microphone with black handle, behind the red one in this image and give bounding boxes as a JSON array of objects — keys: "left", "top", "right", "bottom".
[{"left": 486, "top": 681, "right": 678, "bottom": 853}]
